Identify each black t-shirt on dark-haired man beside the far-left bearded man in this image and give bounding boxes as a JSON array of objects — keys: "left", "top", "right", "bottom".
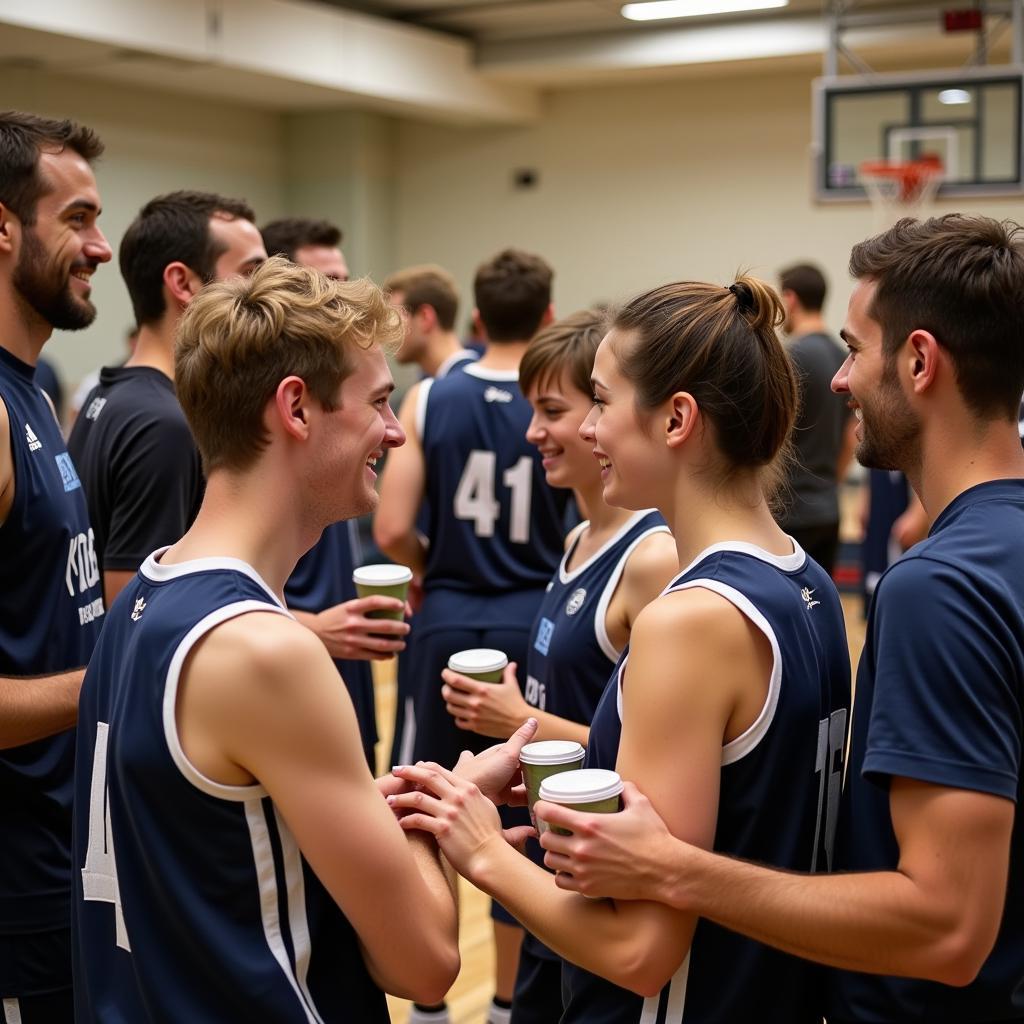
[{"left": 68, "top": 367, "right": 204, "bottom": 571}]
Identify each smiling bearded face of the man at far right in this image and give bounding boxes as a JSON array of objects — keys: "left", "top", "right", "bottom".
[{"left": 831, "top": 281, "right": 921, "bottom": 471}]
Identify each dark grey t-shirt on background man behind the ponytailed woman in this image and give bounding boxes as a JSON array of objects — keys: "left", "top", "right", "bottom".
[{"left": 781, "top": 334, "right": 850, "bottom": 529}]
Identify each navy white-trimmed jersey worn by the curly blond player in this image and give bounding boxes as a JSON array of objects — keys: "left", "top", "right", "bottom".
[{"left": 73, "top": 552, "right": 388, "bottom": 1024}]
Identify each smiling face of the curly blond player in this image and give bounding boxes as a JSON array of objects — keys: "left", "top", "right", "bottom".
[{"left": 314, "top": 345, "right": 406, "bottom": 522}]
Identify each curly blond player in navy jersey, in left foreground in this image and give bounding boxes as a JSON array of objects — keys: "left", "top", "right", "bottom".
[{"left": 74, "top": 260, "right": 468, "bottom": 1022}]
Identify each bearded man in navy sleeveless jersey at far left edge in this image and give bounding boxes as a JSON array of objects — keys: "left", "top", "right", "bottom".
[{"left": 0, "top": 112, "right": 111, "bottom": 1024}]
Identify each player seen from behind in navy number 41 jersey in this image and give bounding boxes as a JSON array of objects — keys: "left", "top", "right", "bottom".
[{"left": 374, "top": 249, "right": 565, "bottom": 1024}]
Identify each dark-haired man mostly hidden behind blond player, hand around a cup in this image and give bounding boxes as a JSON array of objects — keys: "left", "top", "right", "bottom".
[{"left": 262, "top": 217, "right": 409, "bottom": 774}]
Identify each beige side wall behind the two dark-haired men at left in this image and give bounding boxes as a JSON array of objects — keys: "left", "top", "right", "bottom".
[{"left": 6, "top": 71, "right": 284, "bottom": 388}]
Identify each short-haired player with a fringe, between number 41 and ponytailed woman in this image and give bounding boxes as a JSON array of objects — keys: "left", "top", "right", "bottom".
[{"left": 442, "top": 311, "right": 679, "bottom": 1024}]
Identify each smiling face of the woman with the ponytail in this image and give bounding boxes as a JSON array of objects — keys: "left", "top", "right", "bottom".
[{"left": 580, "top": 330, "right": 669, "bottom": 509}]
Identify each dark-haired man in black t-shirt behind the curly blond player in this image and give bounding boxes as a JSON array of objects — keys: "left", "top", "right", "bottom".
[{"left": 68, "top": 191, "right": 266, "bottom": 603}]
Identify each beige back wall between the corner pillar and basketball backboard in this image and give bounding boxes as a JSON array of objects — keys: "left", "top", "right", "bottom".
[{"left": 396, "top": 71, "right": 1024, "bottom": 329}]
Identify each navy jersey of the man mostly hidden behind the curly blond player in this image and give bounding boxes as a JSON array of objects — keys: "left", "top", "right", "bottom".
[{"left": 285, "top": 519, "right": 377, "bottom": 772}]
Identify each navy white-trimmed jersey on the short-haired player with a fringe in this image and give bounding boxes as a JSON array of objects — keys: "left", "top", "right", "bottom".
[{"left": 524, "top": 511, "right": 669, "bottom": 725}]
